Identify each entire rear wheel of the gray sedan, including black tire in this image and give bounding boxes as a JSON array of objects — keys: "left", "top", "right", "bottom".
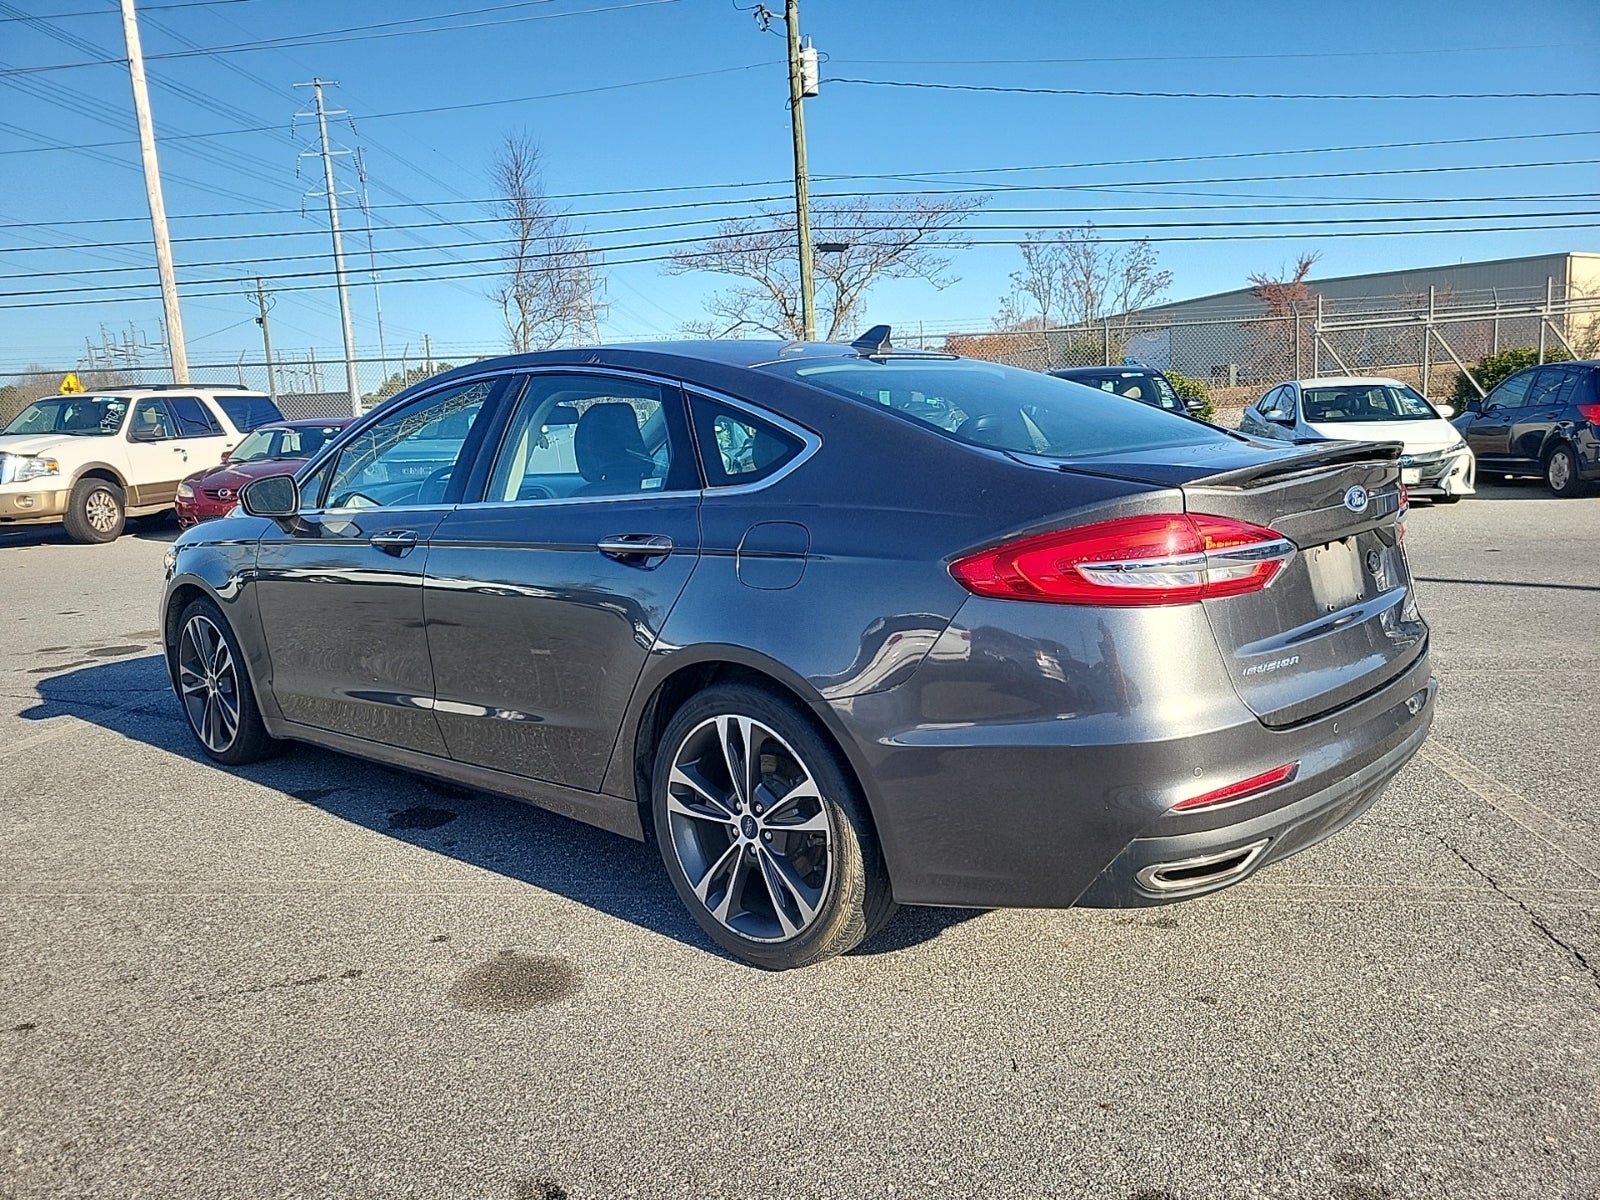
[{"left": 650, "top": 685, "right": 894, "bottom": 971}]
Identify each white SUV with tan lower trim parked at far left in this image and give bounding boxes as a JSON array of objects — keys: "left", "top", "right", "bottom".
[{"left": 0, "top": 384, "right": 283, "bottom": 542}]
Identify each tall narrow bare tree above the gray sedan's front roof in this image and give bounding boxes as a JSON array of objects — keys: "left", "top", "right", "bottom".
[{"left": 490, "top": 134, "right": 600, "bottom": 352}]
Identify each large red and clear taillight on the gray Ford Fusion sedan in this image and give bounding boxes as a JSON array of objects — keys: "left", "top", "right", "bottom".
[{"left": 950, "top": 512, "right": 1294, "bottom": 605}]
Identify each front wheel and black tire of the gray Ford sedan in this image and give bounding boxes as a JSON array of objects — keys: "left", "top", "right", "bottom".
[{"left": 173, "top": 597, "right": 283, "bottom": 766}]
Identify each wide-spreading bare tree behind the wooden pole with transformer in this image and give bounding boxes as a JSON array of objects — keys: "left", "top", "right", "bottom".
[{"left": 666, "top": 197, "right": 982, "bottom": 341}]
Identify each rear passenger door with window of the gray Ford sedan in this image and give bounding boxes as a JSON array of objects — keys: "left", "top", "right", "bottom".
[{"left": 424, "top": 370, "right": 701, "bottom": 790}]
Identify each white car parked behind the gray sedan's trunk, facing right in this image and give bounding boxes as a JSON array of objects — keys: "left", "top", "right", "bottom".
[{"left": 1238, "top": 376, "right": 1477, "bottom": 504}]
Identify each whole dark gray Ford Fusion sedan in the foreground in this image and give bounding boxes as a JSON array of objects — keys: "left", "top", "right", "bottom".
[{"left": 162, "top": 334, "right": 1435, "bottom": 968}]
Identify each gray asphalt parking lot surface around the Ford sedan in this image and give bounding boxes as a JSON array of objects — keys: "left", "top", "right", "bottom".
[{"left": 0, "top": 485, "right": 1600, "bottom": 1200}]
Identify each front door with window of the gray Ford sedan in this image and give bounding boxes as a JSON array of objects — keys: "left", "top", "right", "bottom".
[{"left": 254, "top": 376, "right": 512, "bottom": 755}]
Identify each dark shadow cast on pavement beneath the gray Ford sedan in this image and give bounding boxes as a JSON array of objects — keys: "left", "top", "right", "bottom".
[{"left": 21, "top": 654, "right": 982, "bottom": 957}]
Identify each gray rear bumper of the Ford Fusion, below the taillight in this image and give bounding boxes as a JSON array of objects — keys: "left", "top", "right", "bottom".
[{"left": 832, "top": 602, "right": 1437, "bottom": 907}]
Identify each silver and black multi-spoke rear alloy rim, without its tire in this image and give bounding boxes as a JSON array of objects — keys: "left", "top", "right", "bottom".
[{"left": 667, "top": 715, "right": 835, "bottom": 942}]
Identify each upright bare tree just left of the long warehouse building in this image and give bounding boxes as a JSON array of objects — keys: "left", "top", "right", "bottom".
[{"left": 1000, "top": 224, "right": 1173, "bottom": 330}]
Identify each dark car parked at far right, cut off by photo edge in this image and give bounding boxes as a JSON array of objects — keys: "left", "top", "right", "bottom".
[{"left": 1454, "top": 360, "right": 1600, "bottom": 496}]
